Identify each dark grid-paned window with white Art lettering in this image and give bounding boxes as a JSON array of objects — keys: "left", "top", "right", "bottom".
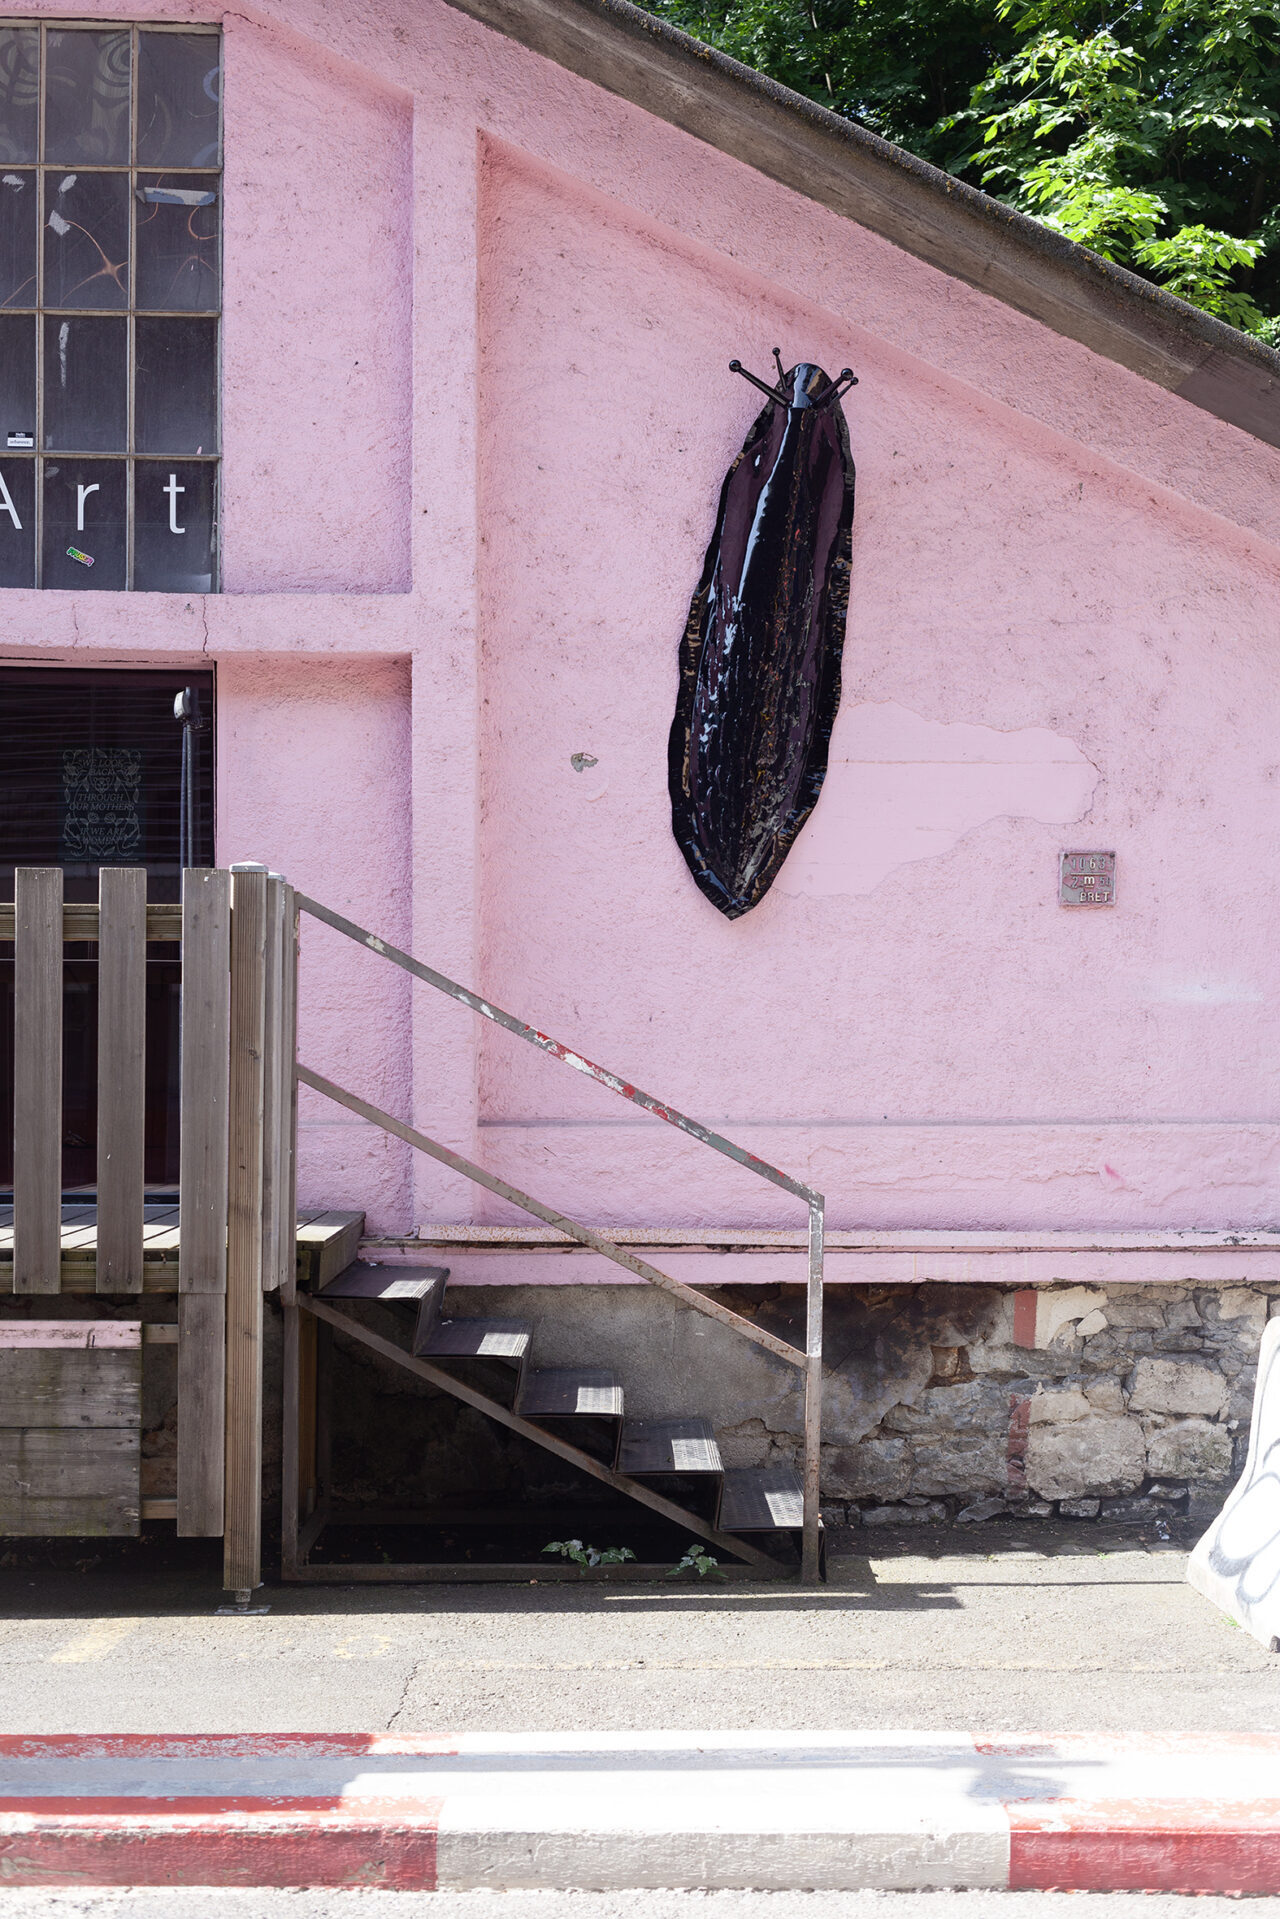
[{"left": 0, "top": 21, "right": 223, "bottom": 593}]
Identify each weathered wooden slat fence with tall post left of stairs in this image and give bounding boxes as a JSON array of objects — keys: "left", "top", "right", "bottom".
[{"left": 0, "top": 867, "right": 297, "bottom": 1593}]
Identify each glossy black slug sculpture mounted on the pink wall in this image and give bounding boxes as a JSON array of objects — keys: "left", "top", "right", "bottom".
[{"left": 668, "top": 347, "right": 858, "bottom": 919}]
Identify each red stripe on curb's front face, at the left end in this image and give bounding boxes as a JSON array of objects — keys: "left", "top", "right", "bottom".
[{"left": 0, "top": 1800, "right": 441, "bottom": 1892}]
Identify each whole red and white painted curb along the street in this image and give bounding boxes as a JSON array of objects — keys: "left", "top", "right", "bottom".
[{"left": 0, "top": 1731, "right": 1280, "bottom": 1894}]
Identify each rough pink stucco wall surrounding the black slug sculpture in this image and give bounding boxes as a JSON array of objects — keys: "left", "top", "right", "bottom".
[{"left": 0, "top": 0, "right": 1280, "bottom": 1228}]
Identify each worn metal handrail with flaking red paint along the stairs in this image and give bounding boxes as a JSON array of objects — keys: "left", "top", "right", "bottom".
[{"left": 296, "top": 892, "right": 825, "bottom": 1583}]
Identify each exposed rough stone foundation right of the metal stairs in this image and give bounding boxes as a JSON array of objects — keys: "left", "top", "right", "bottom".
[{"left": 823, "top": 1286, "right": 1280, "bottom": 1526}]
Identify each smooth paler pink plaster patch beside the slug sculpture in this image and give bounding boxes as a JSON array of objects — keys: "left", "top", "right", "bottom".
[{"left": 773, "top": 700, "right": 1100, "bottom": 896}]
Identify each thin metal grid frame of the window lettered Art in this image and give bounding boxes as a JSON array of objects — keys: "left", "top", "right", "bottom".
[{"left": 0, "top": 15, "right": 226, "bottom": 597}]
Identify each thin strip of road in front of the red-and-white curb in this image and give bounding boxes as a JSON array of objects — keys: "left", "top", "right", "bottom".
[{"left": 0, "top": 1886, "right": 1280, "bottom": 1919}]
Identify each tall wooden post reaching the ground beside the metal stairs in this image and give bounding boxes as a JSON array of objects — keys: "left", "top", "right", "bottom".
[{"left": 223, "top": 865, "right": 269, "bottom": 1602}]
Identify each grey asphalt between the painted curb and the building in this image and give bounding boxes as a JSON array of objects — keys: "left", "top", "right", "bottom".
[{"left": 0, "top": 1528, "right": 1280, "bottom": 1742}]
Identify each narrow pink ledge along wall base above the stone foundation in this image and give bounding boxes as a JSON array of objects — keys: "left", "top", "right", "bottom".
[{"left": 361, "top": 1222, "right": 1280, "bottom": 1286}]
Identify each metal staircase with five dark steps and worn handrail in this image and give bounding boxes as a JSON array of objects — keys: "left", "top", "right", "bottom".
[{"left": 282, "top": 888, "right": 825, "bottom": 1583}]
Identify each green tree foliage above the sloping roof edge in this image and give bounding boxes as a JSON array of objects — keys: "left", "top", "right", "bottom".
[{"left": 651, "top": 0, "right": 1280, "bottom": 345}]
